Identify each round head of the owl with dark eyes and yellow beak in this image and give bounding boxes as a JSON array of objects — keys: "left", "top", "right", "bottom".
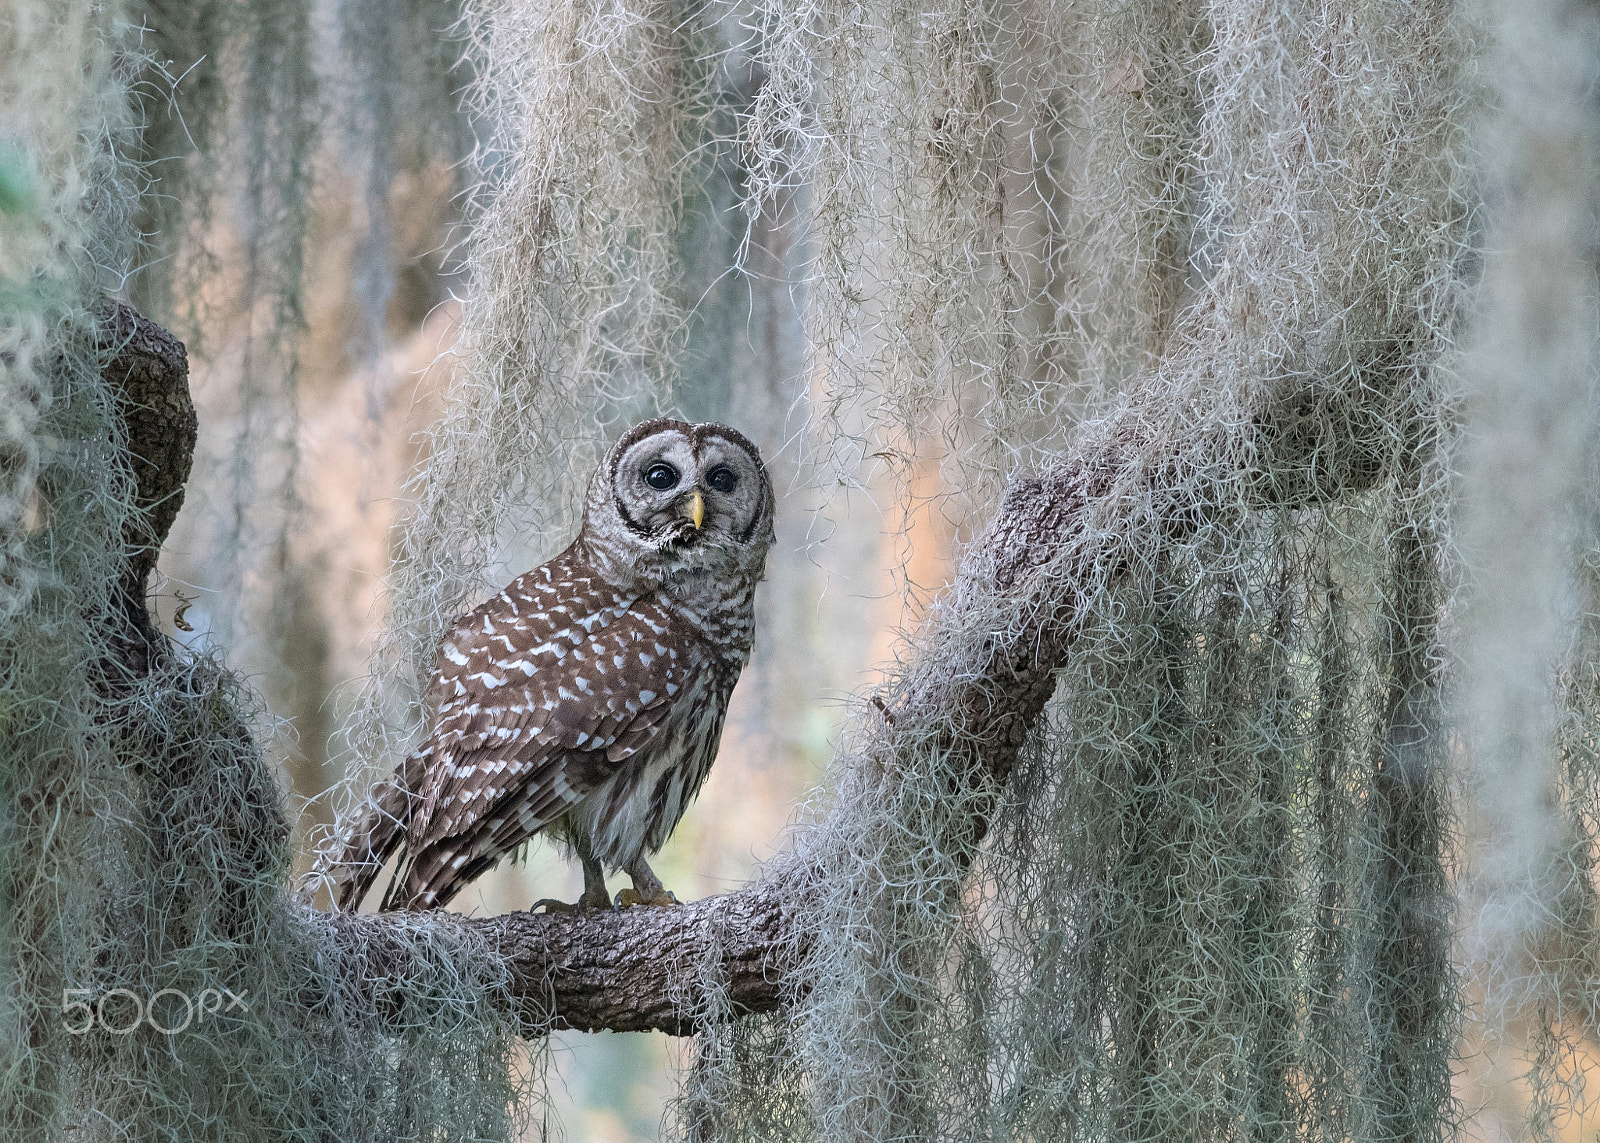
[{"left": 584, "top": 419, "right": 773, "bottom": 578}]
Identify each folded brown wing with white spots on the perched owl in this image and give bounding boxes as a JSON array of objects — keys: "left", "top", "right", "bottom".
[{"left": 406, "top": 557, "right": 701, "bottom": 904}]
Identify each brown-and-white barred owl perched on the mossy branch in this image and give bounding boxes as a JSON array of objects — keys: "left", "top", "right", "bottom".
[{"left": 333, "top": 419, "right": 773, "bottom": 909}]
